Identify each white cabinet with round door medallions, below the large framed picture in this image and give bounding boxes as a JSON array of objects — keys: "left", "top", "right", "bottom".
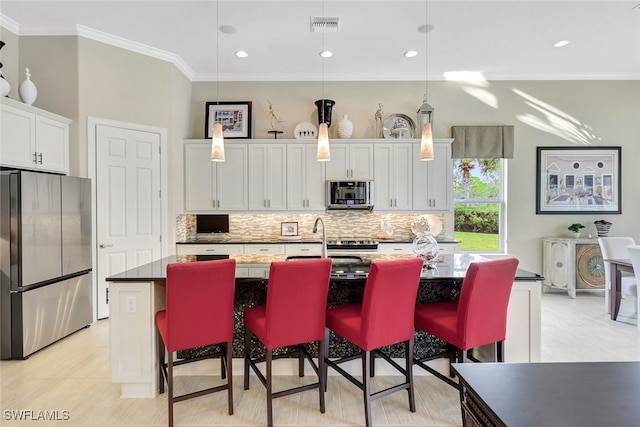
[{"left": 542, "top": 237, "right": 605, "bottom": 298}]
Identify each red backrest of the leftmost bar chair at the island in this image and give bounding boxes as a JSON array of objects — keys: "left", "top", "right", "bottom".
[{"left": 164, "top": 259, "right": 236, "bottom": 352}]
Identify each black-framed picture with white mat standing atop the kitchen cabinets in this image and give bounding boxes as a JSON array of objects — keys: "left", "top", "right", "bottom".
[{"left": 204, "top": 101, "right": 251, "bottom": 139}]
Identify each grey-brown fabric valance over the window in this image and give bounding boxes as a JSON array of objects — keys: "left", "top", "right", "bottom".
[{"left": 451, "top": 126, "right": 513, "bottom": 159}]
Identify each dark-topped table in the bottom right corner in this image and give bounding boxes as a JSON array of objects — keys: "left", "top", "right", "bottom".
[{"left": 452, "top": 362, "right": 640, "bottom": 427}]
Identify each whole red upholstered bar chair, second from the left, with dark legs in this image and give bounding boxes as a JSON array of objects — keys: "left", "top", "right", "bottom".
[{"left": 244, "top": 258, "right": 331, "bottom": 426}]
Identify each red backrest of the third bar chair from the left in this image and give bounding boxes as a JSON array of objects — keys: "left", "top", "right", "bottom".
[{"left": 361, "top": 258, "right": 422, "bottom": 351}]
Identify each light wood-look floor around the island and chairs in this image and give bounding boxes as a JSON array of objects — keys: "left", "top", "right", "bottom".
[{"left": 0, "top": 292, "right": 640, "bottom": 427}]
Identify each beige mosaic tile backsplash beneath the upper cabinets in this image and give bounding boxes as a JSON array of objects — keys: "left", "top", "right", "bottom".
[{"left": 176, "top": 211, "right": 445, "bottom": 242}]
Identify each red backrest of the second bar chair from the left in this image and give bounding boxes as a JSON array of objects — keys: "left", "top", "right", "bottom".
[{"left": 264, "top": 258, "right": 331, "bottom": 348}]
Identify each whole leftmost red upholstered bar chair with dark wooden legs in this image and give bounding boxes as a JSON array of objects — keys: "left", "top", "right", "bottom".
[{"left": 156, "top": 259, "right": 236, "bottom": 426}]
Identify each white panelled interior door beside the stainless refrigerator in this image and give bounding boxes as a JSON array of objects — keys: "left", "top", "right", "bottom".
[{"left": 95, "top": 124, "right": 162, "bottom": 319}]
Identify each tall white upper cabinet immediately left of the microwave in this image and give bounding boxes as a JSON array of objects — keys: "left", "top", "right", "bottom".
[{"left": 287, "top": 143, "right": 326, "bottom": 212}]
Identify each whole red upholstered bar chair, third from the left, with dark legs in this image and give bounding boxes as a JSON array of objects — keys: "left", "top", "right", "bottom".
[{"left": 323, "top": 258, "right": 422, "bottom": 426}]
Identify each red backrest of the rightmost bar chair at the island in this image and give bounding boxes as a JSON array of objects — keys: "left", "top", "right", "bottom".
[{"left": 457, "top": 258, "right": 518, "bottom": 350}]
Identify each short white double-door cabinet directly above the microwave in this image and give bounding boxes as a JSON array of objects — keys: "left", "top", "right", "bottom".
[{"left": 327, "top": 140, "right": 374, "bottom": 180}]
